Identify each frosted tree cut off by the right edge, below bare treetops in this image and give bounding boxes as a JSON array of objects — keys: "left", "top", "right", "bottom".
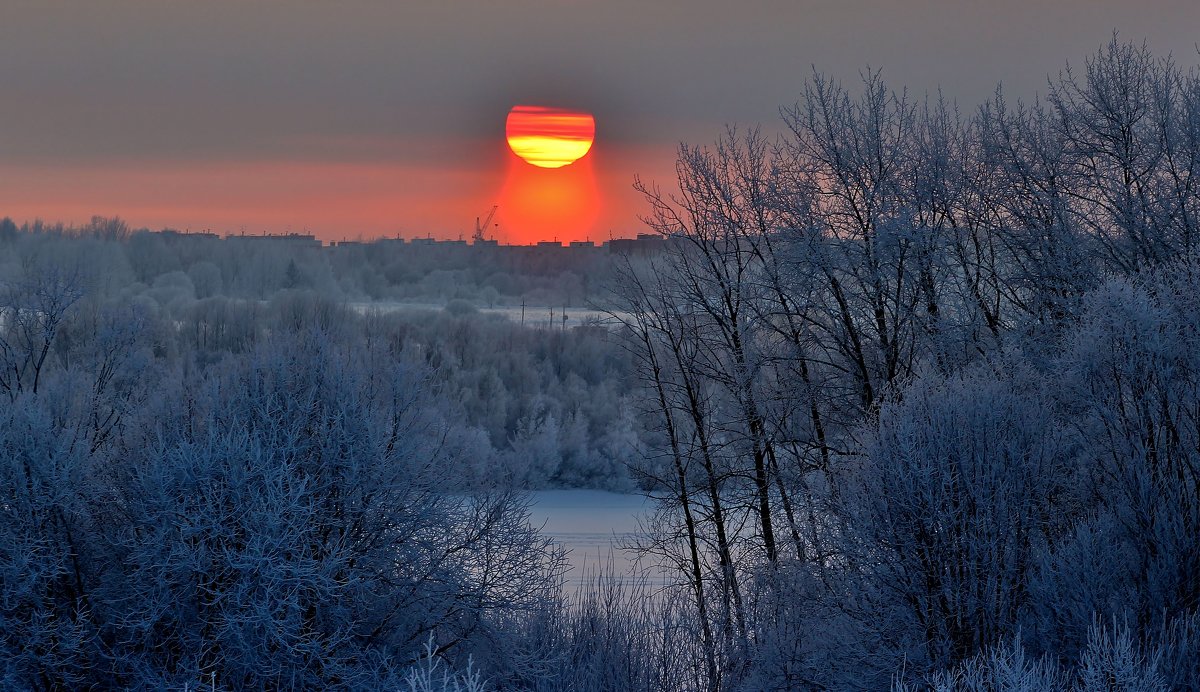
[{"left": 1036, "top": 260, "right": 1200, "bottom": 651}]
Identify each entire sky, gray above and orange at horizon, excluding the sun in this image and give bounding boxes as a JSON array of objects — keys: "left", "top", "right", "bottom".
[{"left": 0, "top": 0, "right": 1200, "bottom": 243}]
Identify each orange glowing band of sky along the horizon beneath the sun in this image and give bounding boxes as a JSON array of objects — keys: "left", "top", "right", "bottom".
[{"left": 0, "top": 131, "right": 674, "bottom": 245}]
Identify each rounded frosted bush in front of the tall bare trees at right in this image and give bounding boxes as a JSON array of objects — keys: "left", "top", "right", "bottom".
[{"left": 844, "top": 366, "right": 1069, "bottom": 667}]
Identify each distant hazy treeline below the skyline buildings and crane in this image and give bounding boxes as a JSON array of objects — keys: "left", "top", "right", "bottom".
[{"left": 0, "top": 216, "right": 611, "bottom": 307}]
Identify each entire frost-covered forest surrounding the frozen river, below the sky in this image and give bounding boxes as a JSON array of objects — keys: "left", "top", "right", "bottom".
[{"left": 0, "top": 37, "right": 1200, "bottom": 691}]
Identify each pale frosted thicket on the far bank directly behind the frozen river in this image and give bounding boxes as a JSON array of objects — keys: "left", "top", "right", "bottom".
[{"left": 370, "top": 305, "right": 646, "bottom": 491}]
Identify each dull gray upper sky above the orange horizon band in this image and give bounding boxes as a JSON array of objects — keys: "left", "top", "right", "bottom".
[{"left": 0, "top": 0, "right": 1200, "bottom": 237}]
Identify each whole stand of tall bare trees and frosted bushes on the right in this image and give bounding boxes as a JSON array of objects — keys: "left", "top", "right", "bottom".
[{"left": 609, "top": 40, "right": 1200, "bottom": 690}]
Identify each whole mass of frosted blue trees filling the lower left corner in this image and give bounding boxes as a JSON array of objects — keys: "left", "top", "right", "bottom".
[{"left": 0, "top": 320, "right": 558, "bottom": 688}]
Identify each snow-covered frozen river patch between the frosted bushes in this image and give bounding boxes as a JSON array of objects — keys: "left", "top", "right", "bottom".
[{"left": 529, "top": 491, "right": 662, "bottom": 590}]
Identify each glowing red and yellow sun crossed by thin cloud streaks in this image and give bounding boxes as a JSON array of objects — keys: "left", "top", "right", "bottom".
[{"left": 504, "top": 106, "right": 596, "bottom": 168}]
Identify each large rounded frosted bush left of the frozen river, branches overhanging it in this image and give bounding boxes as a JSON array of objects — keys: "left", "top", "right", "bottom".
[{"left": 91, "top": 332, "right": 552, "bottom": 687}]
